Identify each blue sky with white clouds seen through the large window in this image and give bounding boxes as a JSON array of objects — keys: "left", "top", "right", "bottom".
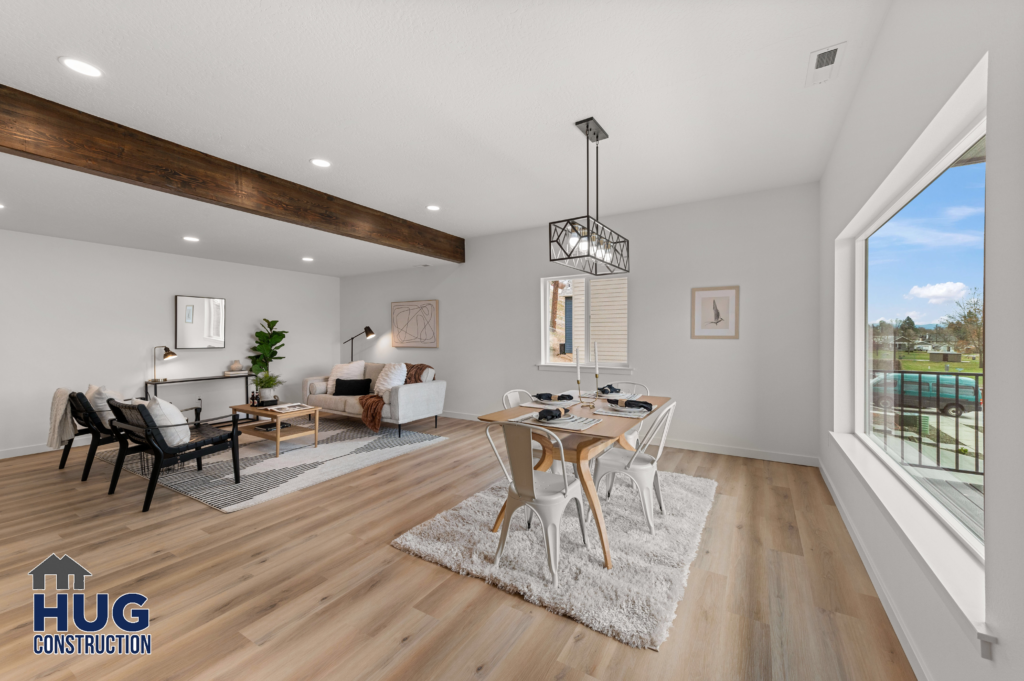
[{"left": 867, "top": 163, "right": 985, "bottom": 325}]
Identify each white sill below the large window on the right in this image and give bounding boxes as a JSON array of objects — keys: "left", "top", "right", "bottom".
[{"left": 831, "top": 432, "right": 987, "bottom": 641}]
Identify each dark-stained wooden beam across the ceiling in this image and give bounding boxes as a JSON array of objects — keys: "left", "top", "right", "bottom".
[{"left": 0, "top": 85, "right": 466, "bottom": 262}]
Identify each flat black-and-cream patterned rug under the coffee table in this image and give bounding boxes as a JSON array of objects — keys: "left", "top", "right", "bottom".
[{"left": 96, "top": 417, "right": 447, "bottom": 513}]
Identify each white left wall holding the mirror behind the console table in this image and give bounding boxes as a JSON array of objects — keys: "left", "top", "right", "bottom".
[{"left": 0, "top": 230, "right": 341, "bottom": 458}]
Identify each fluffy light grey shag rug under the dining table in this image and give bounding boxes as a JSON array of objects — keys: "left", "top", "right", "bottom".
[{"left": 391, "top": 472, "right": 718, "bottom": 649}]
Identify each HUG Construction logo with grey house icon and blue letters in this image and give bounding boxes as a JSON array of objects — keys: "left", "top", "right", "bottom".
[{"left": 29, "top": 553, "right": 153, "bottom": 655}]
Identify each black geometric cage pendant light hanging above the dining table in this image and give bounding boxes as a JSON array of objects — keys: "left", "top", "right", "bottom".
[{"left": 548, "top": 118, "right": 630, "bottom": 275}]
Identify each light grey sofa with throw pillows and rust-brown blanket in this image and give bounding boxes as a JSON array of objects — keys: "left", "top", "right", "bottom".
[{"left": 302, "top": 361, "right": 447, "bottom": 435}]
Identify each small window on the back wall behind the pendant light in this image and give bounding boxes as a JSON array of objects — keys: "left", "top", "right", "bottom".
[{"left": 541, "top": 276, "right": 629, "bottom": 367}]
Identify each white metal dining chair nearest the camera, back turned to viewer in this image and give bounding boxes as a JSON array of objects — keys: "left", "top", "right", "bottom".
[{"left": 486, "top": 423, "right": 590, "bottom": 589}]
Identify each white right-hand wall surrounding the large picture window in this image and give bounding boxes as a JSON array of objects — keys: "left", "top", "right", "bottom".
[{"left": 818, "top": 0, "right": 1024, "bottom": 680}]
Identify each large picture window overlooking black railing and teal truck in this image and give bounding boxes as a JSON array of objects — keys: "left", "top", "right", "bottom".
[{"left": 864, "top": 137, "right": 985, "bottom": 541}]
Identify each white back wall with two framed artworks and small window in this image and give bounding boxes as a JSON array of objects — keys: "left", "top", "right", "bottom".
[{"left": 339, "top": 184, "right": 818, "bottom": 465}]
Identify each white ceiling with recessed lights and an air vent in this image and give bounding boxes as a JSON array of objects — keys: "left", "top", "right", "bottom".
[{"left": 0, "top": 0, "right": 889, "bottom": 269}]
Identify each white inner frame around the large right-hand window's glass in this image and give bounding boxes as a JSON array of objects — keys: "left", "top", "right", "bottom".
[{"left": 852, "top": 116, "right": 987, "bottom": 563}]
